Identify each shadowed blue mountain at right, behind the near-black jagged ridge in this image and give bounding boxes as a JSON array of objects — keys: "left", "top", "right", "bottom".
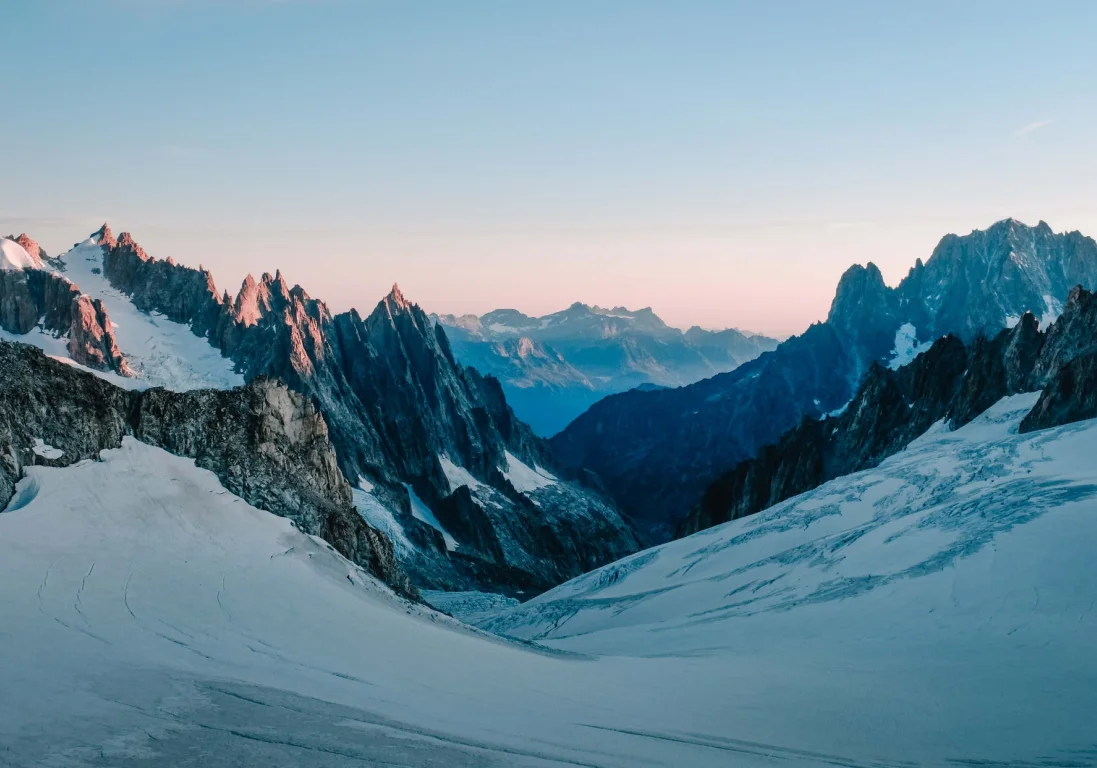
[{"left": 552, "top": 219, "right": 1097, "bottom": 540}]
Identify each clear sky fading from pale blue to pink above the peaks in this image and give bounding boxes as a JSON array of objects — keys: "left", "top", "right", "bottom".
[{"left": 0, "top": 0, "right": 1097, "bottom": 335}]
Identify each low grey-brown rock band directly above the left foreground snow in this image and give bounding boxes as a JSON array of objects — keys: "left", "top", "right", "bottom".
[{"left": 0, "top": 342, "right": 415, "bottom": 597}]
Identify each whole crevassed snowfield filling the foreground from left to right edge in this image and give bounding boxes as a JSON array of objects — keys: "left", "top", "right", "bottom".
[{"left": 0, "top": 397, "right": 1097, "bottom": 768}]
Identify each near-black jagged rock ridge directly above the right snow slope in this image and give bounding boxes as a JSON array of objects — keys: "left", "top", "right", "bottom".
[{"left": 677, "top": 289, "right": 1097, "bottom": 537}]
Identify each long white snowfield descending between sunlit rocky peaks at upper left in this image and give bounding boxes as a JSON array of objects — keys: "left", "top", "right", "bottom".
[{"left": 61, "top": 239, "right": 244, "bottom": 392}]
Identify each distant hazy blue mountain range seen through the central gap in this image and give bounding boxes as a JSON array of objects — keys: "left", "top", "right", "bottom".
[{"left": 432, "top": 302, "right": 777, "bottom": 436}]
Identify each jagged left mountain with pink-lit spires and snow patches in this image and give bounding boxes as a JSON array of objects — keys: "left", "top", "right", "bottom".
[{"left": 0, "top": 225, "right": 640, "bottom": 592}]
